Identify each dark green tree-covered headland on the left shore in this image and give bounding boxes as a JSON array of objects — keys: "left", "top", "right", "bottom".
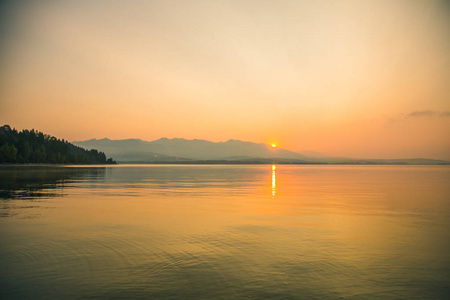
[{"left": 0, "top": 125, "right": 116, "bottom": 164}]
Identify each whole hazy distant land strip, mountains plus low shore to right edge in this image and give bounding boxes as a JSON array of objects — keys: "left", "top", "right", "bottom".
[{"left": 73, "top": 138, "right": 450, "bottom": 164}]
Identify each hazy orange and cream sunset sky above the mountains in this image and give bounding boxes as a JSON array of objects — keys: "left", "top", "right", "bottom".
[{"left": 0, "top": 0, "right": 450, "bottom": 159}]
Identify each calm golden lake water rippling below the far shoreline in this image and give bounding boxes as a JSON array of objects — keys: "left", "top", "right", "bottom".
[{"left": 0, "top": 165, "right": 450, "bottom": 299}]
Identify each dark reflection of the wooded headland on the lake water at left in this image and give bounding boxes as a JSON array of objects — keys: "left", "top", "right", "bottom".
[{"left": 0, "top": 166, "right": 105, "bottom": 199}]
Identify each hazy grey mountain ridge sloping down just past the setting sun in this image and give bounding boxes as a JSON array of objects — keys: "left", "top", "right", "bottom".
[{"left": 73, "top": 138, "right": 311, "bottom": 162}]
